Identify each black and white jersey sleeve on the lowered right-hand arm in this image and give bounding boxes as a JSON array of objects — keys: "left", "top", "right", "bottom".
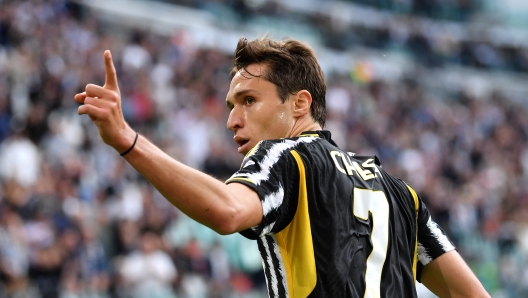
[{"left": 416, "top": 194, "right": 455, "bottom": 281}]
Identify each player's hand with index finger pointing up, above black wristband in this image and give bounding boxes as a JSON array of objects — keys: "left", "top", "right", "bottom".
[{"left": 74, "top": 50, "right": 136, "bottom": 152}]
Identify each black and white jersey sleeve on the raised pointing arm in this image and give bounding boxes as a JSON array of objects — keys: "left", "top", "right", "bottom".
[{"left": 226, "top": 140, "right": 299, "bottom": 239}]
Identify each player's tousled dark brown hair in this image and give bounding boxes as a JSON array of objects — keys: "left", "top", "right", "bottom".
[{"left": 231, "top": 36, "right": 326, "bottom": 127}]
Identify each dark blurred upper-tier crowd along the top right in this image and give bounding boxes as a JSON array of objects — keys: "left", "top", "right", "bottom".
[{"left": 169, "top": 0, "right": 528, "bottom": 73}]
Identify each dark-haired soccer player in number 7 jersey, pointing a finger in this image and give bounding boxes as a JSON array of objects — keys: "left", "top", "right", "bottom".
[{"left": 75, "top": 37, "right": 489, "bottom": 298}]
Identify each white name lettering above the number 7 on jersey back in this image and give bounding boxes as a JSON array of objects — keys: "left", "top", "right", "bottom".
[{"left": 330, "top": 151, "right": 383, "bottom": 180}]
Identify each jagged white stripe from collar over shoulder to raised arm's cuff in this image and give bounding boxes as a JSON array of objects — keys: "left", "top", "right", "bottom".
[{"left": 231, "top": 137, "right": 318, "bottom": 185}]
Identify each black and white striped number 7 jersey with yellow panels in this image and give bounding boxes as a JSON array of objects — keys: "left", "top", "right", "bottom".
[{"left": 226, "top": 131, "right": 454, "bottom": 298}]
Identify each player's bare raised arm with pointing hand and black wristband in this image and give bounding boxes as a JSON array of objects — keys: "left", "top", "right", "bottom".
[{"left": 75, "top": 51, "right": 262, "bottom": 234}]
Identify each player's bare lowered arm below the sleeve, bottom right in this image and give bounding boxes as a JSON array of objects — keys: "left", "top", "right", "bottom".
[{"left": 420, "top": 250, "right": 490, "bottom": 298}]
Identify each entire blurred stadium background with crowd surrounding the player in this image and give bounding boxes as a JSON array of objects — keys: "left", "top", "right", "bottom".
[{"left": 0, "top": 0, "right": 528, "bottom": 298}]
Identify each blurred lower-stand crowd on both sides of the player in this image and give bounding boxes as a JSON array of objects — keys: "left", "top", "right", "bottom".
[{"left": 0, "top": 0, "right": 528, "bottom": 298}]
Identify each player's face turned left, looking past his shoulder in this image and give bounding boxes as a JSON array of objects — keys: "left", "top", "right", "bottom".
[{"left": 226, "top": 64, "right": 295, "bottom": 155}]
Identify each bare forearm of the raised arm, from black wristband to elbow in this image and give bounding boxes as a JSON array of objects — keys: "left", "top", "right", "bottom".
[{"left": 120, "top": 136, "right": 238, "bottom": 233}]
